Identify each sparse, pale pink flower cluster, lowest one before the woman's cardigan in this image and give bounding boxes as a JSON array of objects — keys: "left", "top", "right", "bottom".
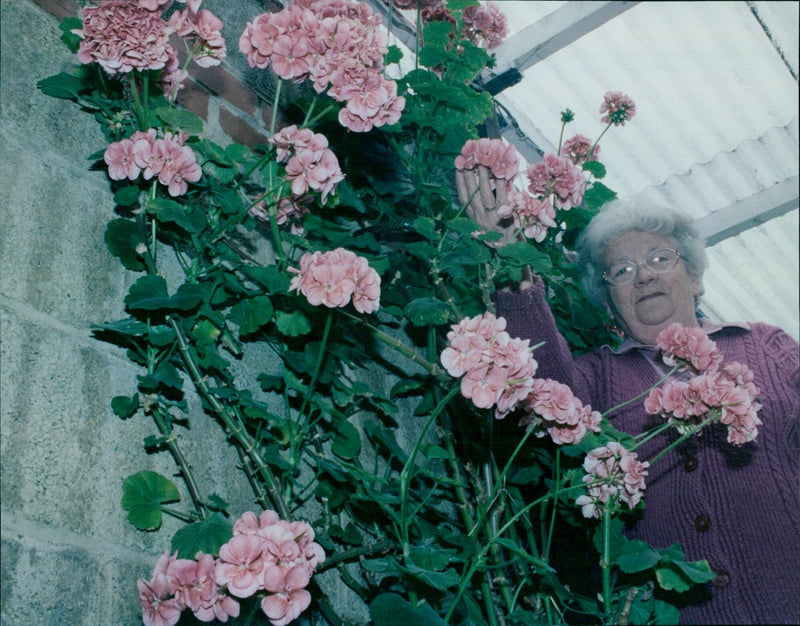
[{"left": 575, "top": 441, "right": 650, "bottom": 518}]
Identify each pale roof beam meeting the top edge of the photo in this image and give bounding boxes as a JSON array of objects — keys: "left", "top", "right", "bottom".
[{"left": 493, "top": 0, "right": 639, "bottom": 74}]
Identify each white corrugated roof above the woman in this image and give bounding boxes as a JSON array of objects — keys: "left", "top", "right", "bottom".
[{"left": 378, "top": 1, "right": 800, "bottom": 338}]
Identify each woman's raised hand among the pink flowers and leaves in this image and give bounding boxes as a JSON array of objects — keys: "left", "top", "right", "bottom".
[{"left": 456, "top": 165, "right": 519, "bottom": 247}]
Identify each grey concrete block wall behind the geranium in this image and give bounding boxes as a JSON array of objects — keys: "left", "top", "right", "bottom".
[{"left": 0, "top": 0, "right": 366, "bottom": 626}]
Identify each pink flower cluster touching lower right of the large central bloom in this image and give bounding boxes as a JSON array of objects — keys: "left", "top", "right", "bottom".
[{"left": 520, "top": 378, "right": 602, "bottom": 445}]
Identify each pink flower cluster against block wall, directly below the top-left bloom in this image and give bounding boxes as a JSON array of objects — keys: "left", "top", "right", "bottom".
[{"left": 103, "top": 128, "right": 203, "bottom": 197}]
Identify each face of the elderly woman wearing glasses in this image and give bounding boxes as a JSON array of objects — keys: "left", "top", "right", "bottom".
[{"left": 603, "top": 230, "right": 700, "bottom": 345}]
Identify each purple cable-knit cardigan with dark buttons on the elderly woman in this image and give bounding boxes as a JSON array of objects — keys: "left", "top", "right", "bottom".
[{"left": 494, "top": 277, "right": 800, "bottom": 624}]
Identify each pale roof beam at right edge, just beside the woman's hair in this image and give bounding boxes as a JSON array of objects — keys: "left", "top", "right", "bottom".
[{"left": 695, "top": 176, "right": 800, "bottom": 246}]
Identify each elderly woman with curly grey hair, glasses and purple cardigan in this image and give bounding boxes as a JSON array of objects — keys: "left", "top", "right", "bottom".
[{"left": 494, "top": 203, "right": 800, "bottom": 624}]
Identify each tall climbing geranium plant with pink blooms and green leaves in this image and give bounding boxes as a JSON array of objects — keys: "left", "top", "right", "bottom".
[{"left": 40, "top": 0, "right": 758, "bottom": 626}]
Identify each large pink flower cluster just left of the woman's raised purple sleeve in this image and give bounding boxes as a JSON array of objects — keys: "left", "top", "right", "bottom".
[{"left": 440, "top": 311, "right": 538, "bottom": 419}]
